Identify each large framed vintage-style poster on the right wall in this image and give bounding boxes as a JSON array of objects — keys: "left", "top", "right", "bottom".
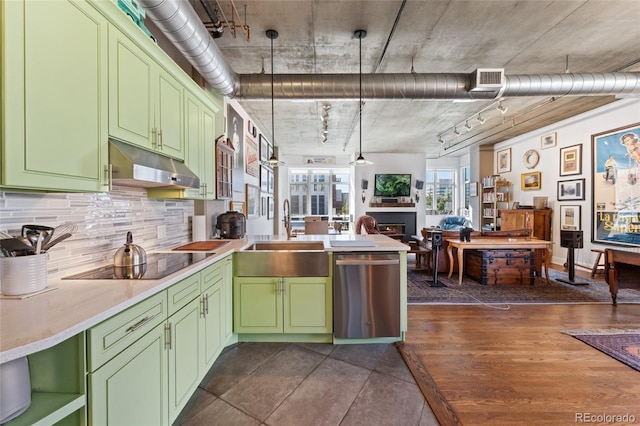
[{"left": 591, "top": 123, "right": 640, "bottom": 247}]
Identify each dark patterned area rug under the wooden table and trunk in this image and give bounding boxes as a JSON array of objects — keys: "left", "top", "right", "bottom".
[{"left": 407, "top": 269, "right": 640, "bottom": 304}]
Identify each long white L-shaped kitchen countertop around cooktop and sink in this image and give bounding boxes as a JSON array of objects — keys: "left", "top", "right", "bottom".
[{"left": 0, "top": 234, "right": 409, "bottom": 364}]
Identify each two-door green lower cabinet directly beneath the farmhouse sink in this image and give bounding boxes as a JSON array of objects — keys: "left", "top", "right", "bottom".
[{"left": 233, "top": 277, "right": 333, "bottom": 334}]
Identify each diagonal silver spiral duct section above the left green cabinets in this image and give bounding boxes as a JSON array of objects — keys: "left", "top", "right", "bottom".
[{"left": 138, "top": 0, "right": 239, "bottom": 97}]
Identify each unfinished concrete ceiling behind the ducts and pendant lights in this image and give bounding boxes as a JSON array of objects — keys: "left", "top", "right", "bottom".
[{"left": 190, "top": 0, "right": 640, "bottom": 158}]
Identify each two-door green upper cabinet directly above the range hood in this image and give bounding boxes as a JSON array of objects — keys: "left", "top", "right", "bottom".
[{"left": 109, "top": 26, "right": 185, "bottom": 160}]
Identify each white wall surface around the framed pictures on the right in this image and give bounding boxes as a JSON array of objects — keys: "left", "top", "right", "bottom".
[{"left": 494, "top": 99, "right": 640, "bottom": 268}]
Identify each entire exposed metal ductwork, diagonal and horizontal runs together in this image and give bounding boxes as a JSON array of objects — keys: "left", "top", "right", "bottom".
[{"left": 138, "top": 0, "right": 640, "bottom": 100}]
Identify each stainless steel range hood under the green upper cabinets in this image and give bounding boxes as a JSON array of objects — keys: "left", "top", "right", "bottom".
[{"left": 109, "top": 139, "right": 200, "bottom": 188}]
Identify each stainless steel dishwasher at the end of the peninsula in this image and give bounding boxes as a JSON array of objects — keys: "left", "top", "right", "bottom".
[{"left": 333, "top": 252, "right": 400, "bottom": 338}]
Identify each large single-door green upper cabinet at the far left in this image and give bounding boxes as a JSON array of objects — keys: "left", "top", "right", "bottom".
[{"left": 0, "top": 0, "right": 109, "bottom": 192}]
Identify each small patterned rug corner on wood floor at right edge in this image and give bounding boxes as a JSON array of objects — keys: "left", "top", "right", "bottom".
[{"left": 563, "top": 329, "right": 640, "bottom": 371}]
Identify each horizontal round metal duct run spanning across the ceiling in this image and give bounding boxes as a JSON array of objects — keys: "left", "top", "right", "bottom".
[{"left": 237, "top": 73, "right": 640, "bottom": 100}]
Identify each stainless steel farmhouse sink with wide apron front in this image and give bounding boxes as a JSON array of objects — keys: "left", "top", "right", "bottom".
[{"left": 234, "top": 241, "right": 329, "bottom": 277}]
